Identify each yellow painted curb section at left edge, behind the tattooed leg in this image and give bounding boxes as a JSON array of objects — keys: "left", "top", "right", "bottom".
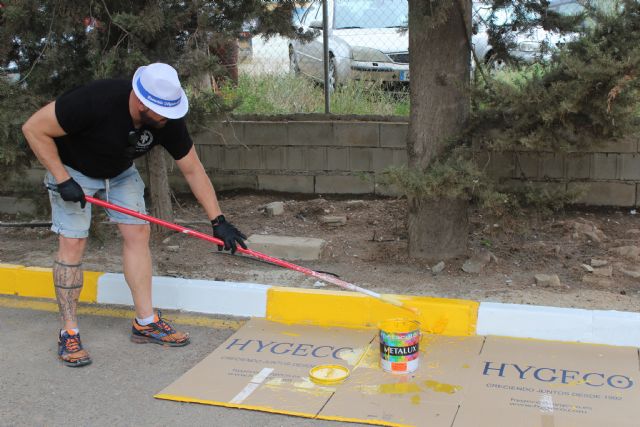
[{"left": 0, "top": 264, "right": 104, "bottom": 302}]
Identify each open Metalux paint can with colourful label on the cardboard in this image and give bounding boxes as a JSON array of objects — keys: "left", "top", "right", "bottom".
[{"left": 380, "top": 319, "right": 420, "bottom": 374}]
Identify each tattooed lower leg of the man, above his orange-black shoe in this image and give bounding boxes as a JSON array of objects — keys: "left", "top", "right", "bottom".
[{"left": 53, "top": 261, "right": 83, "bottom": 323}]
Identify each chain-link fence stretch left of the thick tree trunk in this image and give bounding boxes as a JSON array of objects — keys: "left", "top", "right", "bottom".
[{"left": 230, "top": 0, "right": 410, "bottom": 115}]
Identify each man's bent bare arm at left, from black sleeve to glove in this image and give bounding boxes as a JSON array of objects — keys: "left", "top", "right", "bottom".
[{"left": 22, "top": 101, "right": 70, "bottom": 183}]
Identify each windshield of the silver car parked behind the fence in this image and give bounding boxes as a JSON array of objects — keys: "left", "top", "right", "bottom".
[{"left": 334, "top": 0, "right": 409, "bottom": 30}]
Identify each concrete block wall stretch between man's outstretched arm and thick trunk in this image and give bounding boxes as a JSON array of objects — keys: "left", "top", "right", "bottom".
[{"left": 180, "top": 120, "right": 408, "bottom": 195}]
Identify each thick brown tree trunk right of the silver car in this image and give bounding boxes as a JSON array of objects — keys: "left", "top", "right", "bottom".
[{"left": 407, "top": 0, "right": 471, "bottom": 260}]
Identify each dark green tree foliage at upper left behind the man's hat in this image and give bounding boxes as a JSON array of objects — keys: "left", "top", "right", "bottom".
[{"left": 0, "top": 0, "right": 302, "bottom": 181}]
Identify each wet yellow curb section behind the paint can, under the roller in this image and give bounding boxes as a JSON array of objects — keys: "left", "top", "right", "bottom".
[{"left": 267, "top": 287, "right": 480, "bottom": 336}]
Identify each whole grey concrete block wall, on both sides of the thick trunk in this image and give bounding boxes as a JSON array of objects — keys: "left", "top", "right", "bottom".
[{"left": 5, "top": 118, "right": 640, "bottom": 212}]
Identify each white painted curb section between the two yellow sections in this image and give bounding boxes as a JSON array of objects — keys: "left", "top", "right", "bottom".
[{"left": 97, "top": 273, "right": 271, "bottom": 317}]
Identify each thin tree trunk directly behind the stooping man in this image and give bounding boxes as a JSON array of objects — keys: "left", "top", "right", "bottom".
[{"left": 147, "top": 146, "right": 173, "bottom": 233}]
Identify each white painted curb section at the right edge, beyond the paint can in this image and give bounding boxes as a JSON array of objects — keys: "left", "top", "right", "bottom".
[{"left": 476, "top": 302, "right": 640, "bottom": 347}]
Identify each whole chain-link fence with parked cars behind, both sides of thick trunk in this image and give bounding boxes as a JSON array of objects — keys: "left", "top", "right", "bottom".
[{"left": 226, "top": 0, "right": 600, "bottom": 116}]
